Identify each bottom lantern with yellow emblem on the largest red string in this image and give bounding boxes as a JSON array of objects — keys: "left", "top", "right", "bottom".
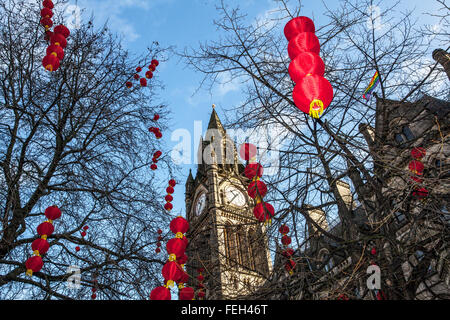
[{"left": 292, "top": 75, "right": 333, "bottom": 118}]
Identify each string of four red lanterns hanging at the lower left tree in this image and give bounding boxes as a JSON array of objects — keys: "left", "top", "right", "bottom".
[{"left": 25, "top": 205, "right": 61, "bottom": 277}]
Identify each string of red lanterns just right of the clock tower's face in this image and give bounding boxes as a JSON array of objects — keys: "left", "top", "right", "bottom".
[{"left": 239, "top": 143, "right": 275, "bottom": 224}]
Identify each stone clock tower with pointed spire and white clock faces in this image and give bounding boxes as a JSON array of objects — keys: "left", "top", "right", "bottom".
[{"left": 186, "top": 106, "right": 272, "bottom": 300}]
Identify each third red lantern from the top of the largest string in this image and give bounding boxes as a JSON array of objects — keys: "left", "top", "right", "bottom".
[{"left": 289, "top": 52, "right": 325, "bottom": 83}]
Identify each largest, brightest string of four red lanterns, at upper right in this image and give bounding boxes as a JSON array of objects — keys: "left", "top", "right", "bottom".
[{"left": 284, "top": 16, "right": 333, "bottom": 118}]
